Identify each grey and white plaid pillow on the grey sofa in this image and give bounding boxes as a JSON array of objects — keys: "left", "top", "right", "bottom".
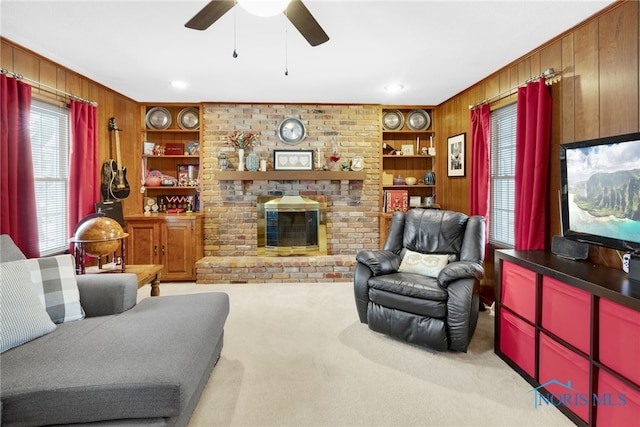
[{"left": 26, "top": 255, "right": 84, "bottom": 323}]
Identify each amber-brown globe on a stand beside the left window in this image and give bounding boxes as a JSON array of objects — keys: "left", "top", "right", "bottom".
[{"left": 71, "top": 217, "right": 128, "bottom": 257}]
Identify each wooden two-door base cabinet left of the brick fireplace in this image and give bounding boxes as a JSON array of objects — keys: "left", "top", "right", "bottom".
[{"left": 125, "top": 213, "right": 203, "bottom": 282}]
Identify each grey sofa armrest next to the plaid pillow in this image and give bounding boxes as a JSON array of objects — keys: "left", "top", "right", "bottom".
[{"left": 76, "top": 273, "right": 138, "bottom": 317}]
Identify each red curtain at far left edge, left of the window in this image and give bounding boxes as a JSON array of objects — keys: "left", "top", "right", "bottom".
[{"left": 0, "top": 74, "right": 40, "bottom": 258}]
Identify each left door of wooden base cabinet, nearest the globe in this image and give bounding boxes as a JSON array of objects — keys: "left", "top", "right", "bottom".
[{"left": 127, "top": 221, "right": 160, "bottom": 264}]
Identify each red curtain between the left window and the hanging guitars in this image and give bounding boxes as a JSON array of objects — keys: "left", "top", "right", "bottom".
[{"left": 68, "top": 100, "right": 100, "bottom": 239}]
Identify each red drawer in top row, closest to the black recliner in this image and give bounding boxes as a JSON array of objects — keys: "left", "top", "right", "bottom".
[{"left": 501, "top": 261, "right": 536, "bottom": 322}]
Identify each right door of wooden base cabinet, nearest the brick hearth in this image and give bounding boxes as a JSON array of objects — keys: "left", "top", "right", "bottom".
[{"left": 161, "top": 220, "right": 195, "bottom": 281}]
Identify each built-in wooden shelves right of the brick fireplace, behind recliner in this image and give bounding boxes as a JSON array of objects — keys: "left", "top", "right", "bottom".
[{"left": 380, "top": 106, "right": 439, "bottom": 246}]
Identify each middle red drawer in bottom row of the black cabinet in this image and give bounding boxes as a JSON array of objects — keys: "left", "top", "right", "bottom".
[{"left": 538, "top": 333, "right": 590, "bottom": 422}]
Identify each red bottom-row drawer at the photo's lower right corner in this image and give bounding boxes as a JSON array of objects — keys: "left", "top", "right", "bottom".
[{"left": 594, "top": 370, "right": 640, "bottom": 427}]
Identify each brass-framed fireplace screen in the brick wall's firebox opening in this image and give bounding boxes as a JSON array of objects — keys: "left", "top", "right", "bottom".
[{"left": 258, "top": 196, "right": 326, "bottom": 255}]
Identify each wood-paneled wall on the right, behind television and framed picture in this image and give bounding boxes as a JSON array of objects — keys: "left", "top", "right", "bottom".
[{"left": 436, "top": 1, "right": 640, "bottom": 278}]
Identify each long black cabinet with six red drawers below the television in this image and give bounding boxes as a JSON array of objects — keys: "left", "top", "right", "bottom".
[{"left": 495, "top": 250, "right": 640, "bottom": 426}]
